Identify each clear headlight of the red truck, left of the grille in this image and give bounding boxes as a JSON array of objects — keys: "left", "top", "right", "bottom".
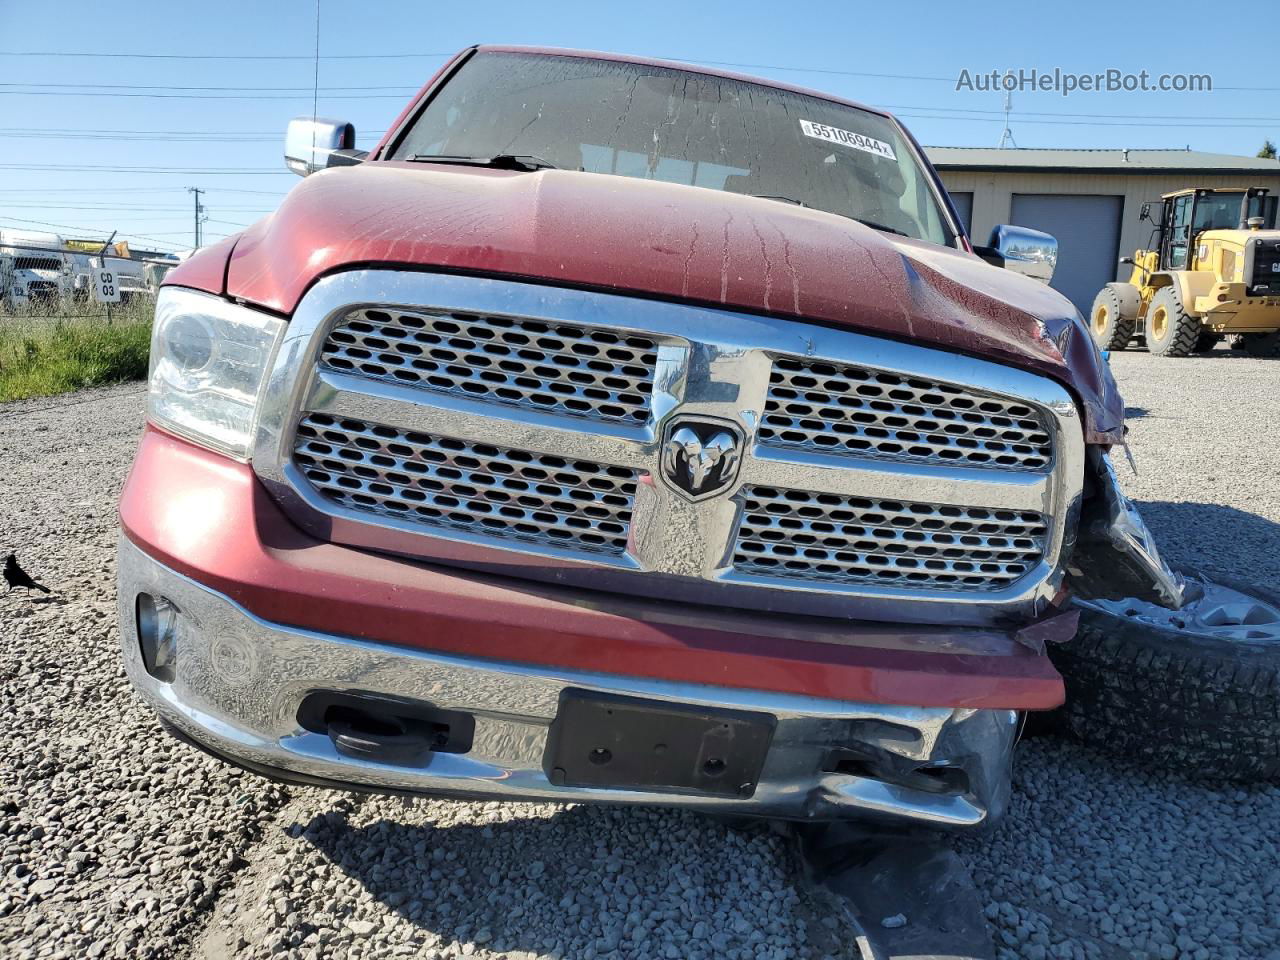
[{"left": 147, "top": 287, "right": 284, "bottom": 460}]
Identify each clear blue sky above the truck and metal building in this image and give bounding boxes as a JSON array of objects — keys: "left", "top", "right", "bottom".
[{"left": 0, "top": 0, "right": 1280, "bottom": 250}]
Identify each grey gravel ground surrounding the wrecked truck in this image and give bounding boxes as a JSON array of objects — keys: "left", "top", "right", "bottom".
[{"left": 0, "top": 351, "right": 1280, "bottom": 960}]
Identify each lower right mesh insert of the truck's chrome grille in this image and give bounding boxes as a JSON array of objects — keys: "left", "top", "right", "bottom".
[{"left": 733, "top": 486, "right": 1047, "bottom": 590}]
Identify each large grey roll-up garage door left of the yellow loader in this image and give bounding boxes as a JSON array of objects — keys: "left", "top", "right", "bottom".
[{"left": 1010, "top": 193, "right": 1124, "bottom": 315}]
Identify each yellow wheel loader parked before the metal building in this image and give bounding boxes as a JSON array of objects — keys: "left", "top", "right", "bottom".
[{"left": 1089, "top": 187, "right": 1280, "bottom": 357}]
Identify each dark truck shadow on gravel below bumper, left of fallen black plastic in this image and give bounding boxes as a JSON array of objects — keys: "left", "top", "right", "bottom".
[{"left": 289, "top": 803, "right": 849, "bottom": 960}]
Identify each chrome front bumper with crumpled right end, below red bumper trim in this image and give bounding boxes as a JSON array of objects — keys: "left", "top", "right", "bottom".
[{"left": 118, "top": 538, "right": 1018, "bottom": 828}]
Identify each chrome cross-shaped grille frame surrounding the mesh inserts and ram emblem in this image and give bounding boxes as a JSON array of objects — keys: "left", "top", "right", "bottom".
[{"left": 253, "top": 270, "right": 1084, "bottom": 625}]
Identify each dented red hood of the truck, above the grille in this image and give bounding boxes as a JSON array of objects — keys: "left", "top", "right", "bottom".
[{"left": 194, "top": 161, "right": 1124, "bottom": 443}]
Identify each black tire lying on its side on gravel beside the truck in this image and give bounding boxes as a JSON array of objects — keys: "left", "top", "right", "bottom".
[{"left": 1050, "top": 571, "right": 1280, "bottom": 782}]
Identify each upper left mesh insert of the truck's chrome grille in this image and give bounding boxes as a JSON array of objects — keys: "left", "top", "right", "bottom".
[{"left": 320, "top": 307, "right": 658, "bottom": 424}]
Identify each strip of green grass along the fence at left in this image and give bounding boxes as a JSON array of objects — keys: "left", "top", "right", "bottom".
[{"left": 0, "top": 305, "right": 151, "bottom": 403}]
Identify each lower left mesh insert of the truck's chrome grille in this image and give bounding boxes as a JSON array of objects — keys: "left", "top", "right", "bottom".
[{"left": 293, "top": 413, "right": 636, "bottom": 553}]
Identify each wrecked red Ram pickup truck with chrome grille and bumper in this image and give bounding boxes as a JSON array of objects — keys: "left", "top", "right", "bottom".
[{"left": 119, "top": 47, "right": 1274, "bottom": 828}]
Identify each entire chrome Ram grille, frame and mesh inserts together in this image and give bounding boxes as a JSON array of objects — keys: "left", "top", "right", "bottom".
[{"left": 252, "top": 269, "right": 1085, "bottom": 626}]
